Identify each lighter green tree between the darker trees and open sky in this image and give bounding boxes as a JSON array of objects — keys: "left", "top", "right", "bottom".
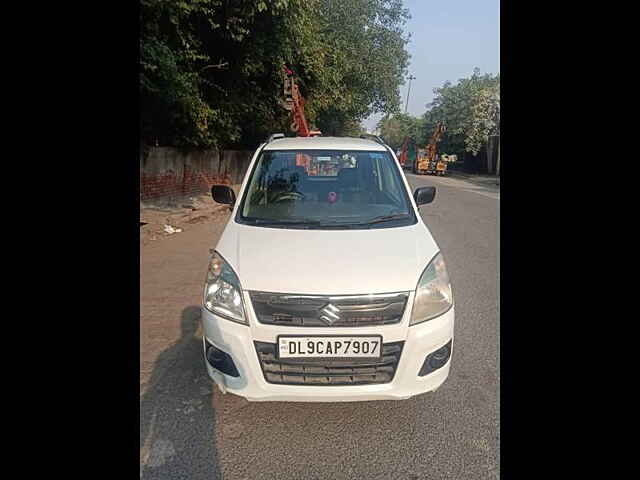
[{"left": 309, "top": 0, "right": 409, "bottom": 135}]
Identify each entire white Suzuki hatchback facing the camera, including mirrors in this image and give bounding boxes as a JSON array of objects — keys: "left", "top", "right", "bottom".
[{"left": 202, "top": 135, "right": 454, "bottom": 402}]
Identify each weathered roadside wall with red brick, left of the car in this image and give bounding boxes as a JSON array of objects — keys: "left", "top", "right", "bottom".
[{"left": 140, "top": 147, "right": 253, "bottom": 201}]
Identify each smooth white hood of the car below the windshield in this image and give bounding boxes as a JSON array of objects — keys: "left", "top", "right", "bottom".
[{"left": 217, "top": 220, "right": 439, "bottom": 295}]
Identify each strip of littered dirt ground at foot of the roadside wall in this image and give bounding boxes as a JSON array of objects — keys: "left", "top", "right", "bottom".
[{"left": 140, "top": 185, "right": 240, "bottom": 246}]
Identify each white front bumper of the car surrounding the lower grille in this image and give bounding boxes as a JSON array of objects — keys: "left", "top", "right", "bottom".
[{"left": 202, "top": 293, "right": 455, "bottom": 402}]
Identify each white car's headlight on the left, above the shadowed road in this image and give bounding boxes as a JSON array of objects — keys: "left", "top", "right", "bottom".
[{"left": 203, "top": 252, "right": 249, "bottom": 325}]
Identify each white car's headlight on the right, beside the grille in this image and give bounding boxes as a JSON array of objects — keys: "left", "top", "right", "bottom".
[{"left": 409, "top": 253, "right": 453, "bottom": 325}]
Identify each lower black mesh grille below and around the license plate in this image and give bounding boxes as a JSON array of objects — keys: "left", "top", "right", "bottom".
[{"left": 254, "top": 342, "right": 404, "bottom": 385}]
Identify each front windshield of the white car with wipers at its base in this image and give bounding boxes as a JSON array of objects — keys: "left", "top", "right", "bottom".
[{"left": 237, "top": 150, "right": 416, "bottom": 228}]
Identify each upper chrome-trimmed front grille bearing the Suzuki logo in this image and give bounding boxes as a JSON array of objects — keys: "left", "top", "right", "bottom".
[{"left": 249, "top": 292, "right": 409, "bottom": 327}]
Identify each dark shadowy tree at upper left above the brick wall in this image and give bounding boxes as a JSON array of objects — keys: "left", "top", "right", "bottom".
[{"left": 140, "top": 0, "right": 320, "bottom": 148}]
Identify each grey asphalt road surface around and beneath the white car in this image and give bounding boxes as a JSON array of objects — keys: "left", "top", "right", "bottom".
[{"left": 140, "top": 174, "right": 500, "bottom": 480}]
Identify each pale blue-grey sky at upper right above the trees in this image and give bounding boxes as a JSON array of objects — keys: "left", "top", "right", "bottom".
[{"left": 363, "top": 0, "right": 500, "bottom": 132}]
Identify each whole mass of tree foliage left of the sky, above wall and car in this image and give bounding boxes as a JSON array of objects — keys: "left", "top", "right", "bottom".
[{"left": 140, "top": 0, "right": 408, "bottom": 148}]
